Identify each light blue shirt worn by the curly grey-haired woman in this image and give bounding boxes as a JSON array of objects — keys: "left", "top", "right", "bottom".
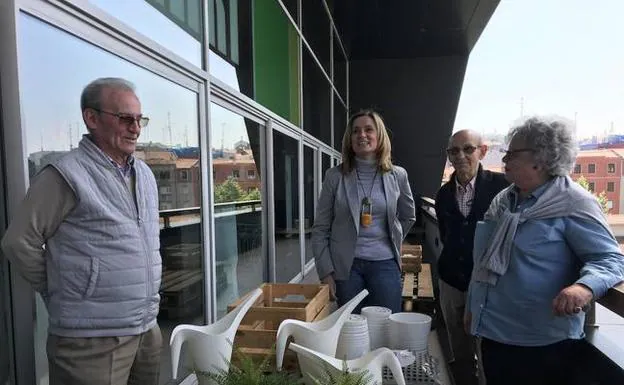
[{"left": 468, "top": 183, "right": 624, "bottom": 346}]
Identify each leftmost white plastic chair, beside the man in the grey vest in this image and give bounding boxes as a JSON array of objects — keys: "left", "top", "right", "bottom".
[{"left": 169, "top": 289, "right": 262, "bottom": 385}]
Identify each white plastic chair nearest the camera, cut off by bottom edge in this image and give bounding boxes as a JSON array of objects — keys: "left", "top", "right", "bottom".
[{"left": 289, "top": 342, "right": 405, "bottom": 385}]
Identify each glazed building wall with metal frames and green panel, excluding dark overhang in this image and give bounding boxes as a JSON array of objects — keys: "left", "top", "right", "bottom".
[{"left": 0, "top": 0, "right": 342, "bottom": 385}]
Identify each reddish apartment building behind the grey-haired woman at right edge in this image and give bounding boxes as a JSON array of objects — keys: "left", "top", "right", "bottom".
[{"left": 571, "top": 148, "right": 624, "bottom": 214}]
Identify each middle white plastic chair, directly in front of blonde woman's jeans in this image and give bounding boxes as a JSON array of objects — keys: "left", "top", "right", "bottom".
[{"left": 275, "top": 289, "right": 368, "bottom": 370}]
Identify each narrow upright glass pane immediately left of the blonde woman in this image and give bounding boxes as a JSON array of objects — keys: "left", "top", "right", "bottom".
[{"left": 303, "top": 146, "right": 318, "bottom": 263}]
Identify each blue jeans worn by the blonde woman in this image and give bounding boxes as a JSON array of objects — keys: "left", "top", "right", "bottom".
[{"left": 336, "top": 258, "right": 402, "bottom": 314}]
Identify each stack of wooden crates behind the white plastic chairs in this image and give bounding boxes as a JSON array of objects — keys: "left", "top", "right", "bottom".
[{"left": 228, "top": 284, "right": 332, "bottom": 371}]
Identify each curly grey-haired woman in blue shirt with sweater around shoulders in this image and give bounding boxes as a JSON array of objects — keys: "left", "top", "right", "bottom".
[{"left": 466, "top": 117, "right": 624, "bottom": 385}]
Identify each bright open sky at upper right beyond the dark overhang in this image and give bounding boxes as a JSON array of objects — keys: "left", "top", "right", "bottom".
[{"left": 454, "top": 0, "right": 624, "bottom": 139}]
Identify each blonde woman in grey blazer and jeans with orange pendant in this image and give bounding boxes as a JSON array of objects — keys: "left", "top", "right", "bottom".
[{"left": 312, "top": 110, "right": 416, "bottom": 313}]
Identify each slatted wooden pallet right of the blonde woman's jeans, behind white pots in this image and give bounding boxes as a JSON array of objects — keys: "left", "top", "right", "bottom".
[{"left": 402, "top": 263, "right": 435, "bottom": 314}]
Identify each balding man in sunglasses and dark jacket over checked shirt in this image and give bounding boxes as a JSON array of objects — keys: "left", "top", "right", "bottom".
[{"left": 435, "top": 130, "right": 508, "bottom": 385}]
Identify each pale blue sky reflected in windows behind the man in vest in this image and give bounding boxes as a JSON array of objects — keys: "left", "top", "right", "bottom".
[{"left": 16, "top": 4, "right": 249, "bottom": 154}]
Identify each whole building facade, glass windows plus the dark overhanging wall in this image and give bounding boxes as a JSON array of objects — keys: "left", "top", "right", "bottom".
[{"left": 0, "top": 0, "right": 498, "bottom": 385}]
